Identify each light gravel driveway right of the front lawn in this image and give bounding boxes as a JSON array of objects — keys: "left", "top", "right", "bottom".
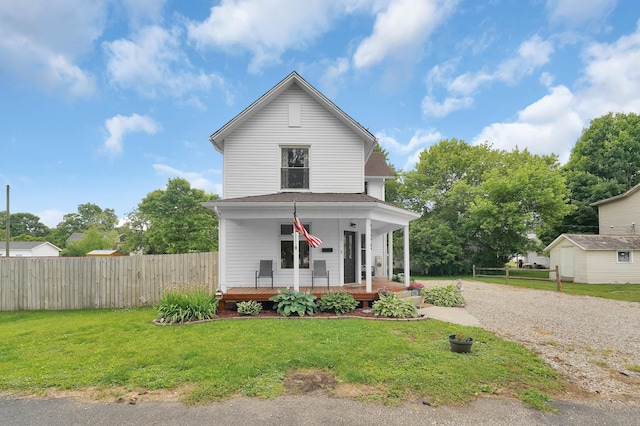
[{"left": 450, "top": 281, "right": 640, "bottom": 402}]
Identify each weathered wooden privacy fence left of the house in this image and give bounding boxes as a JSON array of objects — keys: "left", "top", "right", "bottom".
[{"left": 0, "top": 253, "right": 218, "bottom": 311}]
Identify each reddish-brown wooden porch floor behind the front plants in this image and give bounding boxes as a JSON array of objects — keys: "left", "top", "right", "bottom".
[{"left": 220, "top": 278, "right": 404, "bottom": 310}]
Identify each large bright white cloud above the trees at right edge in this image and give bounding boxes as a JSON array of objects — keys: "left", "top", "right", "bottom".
[{"left": 474, "top": 23, "right": 640, "bottom": 163}]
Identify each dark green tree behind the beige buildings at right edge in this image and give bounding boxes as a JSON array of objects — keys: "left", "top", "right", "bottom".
[{"left": 544, "top": 113, "right": 640, "bottom": 242}]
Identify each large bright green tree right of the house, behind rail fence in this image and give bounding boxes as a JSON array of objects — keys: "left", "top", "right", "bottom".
[{"left": 403, "top": 139, "right": 570, "bottom": 275}]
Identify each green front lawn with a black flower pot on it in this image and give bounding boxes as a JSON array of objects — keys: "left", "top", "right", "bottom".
[{"left": 0, "top": 308, "right": 563, "bottom": 410}]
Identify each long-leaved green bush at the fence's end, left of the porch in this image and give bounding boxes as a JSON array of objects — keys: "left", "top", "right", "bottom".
[{"left": 156, "top": 287, "right": 218, "bottom": 324}]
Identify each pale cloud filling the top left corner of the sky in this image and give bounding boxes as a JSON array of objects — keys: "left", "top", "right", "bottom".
[{"left": 0, "top": 0, "right": 107, "bottom": 98}]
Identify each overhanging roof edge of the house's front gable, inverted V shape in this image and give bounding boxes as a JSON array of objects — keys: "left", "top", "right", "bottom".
[{"left": 209, "top": 71, "right": 376, "bottom": 158}]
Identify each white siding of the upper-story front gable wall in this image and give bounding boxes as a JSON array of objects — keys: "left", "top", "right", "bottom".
[{"left": 223, "top": 86, "right": 364, "bottom": 198}]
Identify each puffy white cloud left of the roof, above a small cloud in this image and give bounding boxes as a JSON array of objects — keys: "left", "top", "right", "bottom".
[{"left": 104, "top": 26, "right": 229, "bottom": 102}]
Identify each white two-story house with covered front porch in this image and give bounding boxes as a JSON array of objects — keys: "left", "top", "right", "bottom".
[{"left": 204, "top": 72, "right": 419, "bottom": 292}]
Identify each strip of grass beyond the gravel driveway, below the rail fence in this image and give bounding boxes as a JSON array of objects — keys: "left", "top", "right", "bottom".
[{"left": 414, "top": 271, "right": 640, "bottom": 302}]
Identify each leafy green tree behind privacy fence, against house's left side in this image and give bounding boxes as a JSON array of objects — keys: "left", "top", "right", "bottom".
[{"left": 121, "top": 178, "right": 218, "bottom": 254}]
